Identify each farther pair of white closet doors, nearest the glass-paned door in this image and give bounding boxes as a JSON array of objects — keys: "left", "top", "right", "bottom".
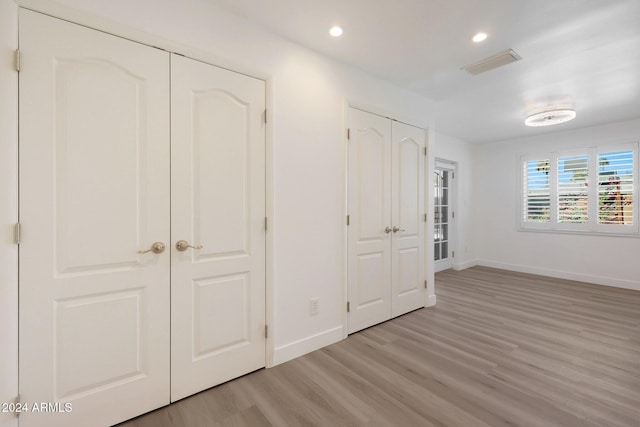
[{"left": 347, "top": 108, "right": 426, "bottom": 333}]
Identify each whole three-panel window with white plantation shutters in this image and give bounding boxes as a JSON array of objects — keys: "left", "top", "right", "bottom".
[{"left": 520, "top": 143, "right": 639, "bottom": 234}]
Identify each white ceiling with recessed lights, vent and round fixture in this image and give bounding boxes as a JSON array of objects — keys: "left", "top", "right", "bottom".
[{"left": 209, "top": 0, "right": 640, "bottom": 143}]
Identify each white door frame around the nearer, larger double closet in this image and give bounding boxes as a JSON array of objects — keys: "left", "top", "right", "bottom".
[{"left": 8, "top": 0, "right": 277, "bottom": 408}]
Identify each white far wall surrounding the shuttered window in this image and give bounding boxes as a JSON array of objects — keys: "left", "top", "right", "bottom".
[{"left": 474, "top": 119, "right": 640, "bottom": 290}]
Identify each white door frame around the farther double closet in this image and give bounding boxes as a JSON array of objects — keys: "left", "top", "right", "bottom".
[{"left": 342, "top": 103, "right": 436, "bottom": 339}]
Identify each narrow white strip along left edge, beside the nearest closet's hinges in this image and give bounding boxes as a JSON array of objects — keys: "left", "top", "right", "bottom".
[{"left": 0, "top": 1, "right": 18, "bottom": 427}]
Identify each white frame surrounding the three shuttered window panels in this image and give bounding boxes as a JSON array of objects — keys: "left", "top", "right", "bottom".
[{"left": 517, "top": 142, "right": 640, "bottom": 237}]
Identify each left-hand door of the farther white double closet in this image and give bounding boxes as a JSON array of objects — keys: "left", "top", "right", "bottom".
[{"left": 347, "top": 108, "right": 392, "bottom": 333}]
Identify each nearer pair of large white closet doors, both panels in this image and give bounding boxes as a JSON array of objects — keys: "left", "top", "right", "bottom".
[{"left": 19, "top": 10, "right": 265, "bottom": 426}]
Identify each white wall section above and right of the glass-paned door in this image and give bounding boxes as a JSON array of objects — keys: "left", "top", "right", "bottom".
[{"left": 429, "top": 132, "right": 477, "bottom": 270}]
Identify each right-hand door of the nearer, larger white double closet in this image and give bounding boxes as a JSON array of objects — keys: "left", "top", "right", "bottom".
[{"left": 171, "top": 55, "right": 265, "bottom": 401}]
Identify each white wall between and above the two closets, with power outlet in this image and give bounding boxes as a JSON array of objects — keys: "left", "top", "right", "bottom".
[{"left": 12, "top": 0, "right": 433, "bottom": 364}]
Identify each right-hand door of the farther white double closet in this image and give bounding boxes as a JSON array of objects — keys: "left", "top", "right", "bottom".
[{"left": 391, "top": 122, "right": 426, "bottom": 317}]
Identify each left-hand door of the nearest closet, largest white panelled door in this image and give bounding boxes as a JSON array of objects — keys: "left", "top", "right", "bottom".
[{"left": 20, "top": 10, "right": 170, "bottom": 427}]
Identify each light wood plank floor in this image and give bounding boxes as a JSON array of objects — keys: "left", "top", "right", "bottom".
[{"left": 121, "top": 267, "right": 640, "bottom": 427}]
